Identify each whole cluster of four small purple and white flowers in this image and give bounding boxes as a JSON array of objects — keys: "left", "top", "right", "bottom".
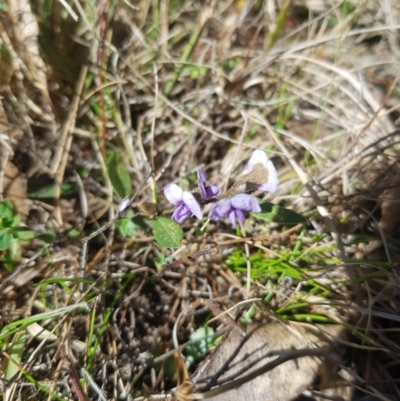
[{"left": 164, "top": 149, "right": 279, "bottom": 227}]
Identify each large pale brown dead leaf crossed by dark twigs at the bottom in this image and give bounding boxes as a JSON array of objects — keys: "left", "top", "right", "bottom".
[{"left": 186, "top": 323, "right": 343, "bottom": 401}]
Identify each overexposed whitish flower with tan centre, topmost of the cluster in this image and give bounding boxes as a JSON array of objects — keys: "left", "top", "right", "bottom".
[{"left": 247, "top": 149, "right": 279, "bottom": 192}]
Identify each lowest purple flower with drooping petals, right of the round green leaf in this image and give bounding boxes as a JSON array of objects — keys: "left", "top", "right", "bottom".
[{"left": 209, "top": 194, "right": 261, "bottom": 227}]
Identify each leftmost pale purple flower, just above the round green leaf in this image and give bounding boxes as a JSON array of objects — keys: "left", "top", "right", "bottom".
[{"left": 164, "top": 184, "right": 203, "bottom": 223}]
